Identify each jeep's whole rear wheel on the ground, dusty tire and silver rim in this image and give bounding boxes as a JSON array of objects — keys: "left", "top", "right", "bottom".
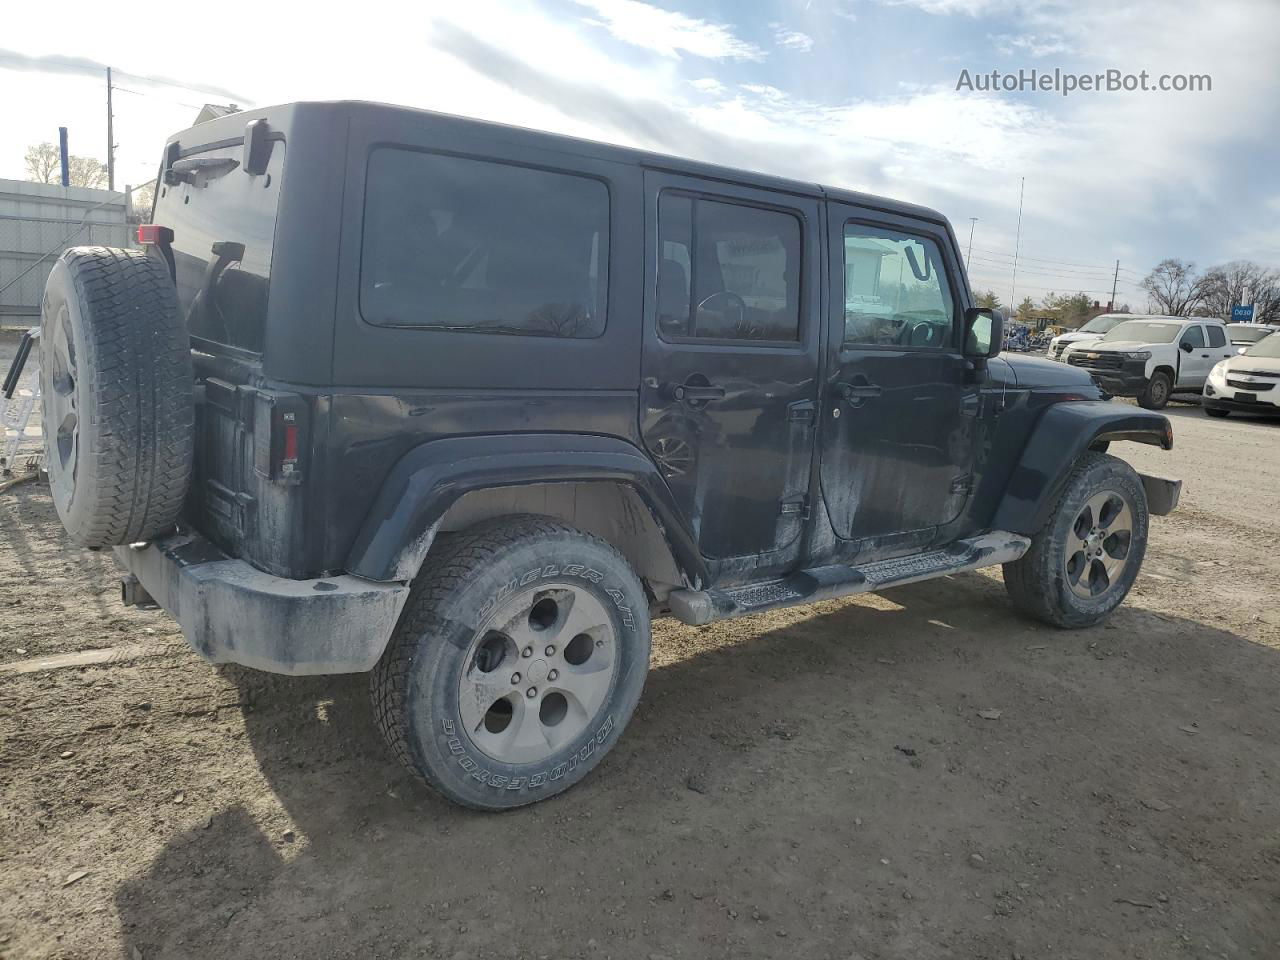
[{"left": 372, "top": 516, "right": 649, "bottom": 810}]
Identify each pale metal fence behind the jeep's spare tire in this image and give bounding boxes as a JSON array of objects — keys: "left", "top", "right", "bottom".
[{"left": 0, "top": 179, "right": 134, "bottom": 326}]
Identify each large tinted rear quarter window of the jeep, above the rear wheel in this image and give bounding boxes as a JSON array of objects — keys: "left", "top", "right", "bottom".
[{"left": 360, "top": 148, "right": 609, "bottom": 338}]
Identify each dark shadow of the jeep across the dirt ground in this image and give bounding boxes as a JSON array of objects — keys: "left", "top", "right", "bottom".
[{"left": 115, "top": 575, "right": 1280, "bottom": 960}]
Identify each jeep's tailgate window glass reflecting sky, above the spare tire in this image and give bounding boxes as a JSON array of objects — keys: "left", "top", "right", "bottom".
[{"left": 155, "top": 142, "right": 284, "bottom": 353}]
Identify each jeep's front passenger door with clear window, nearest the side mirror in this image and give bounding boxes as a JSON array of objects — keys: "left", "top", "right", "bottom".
[{"left": 822, "top": 204, "right": 980, "bottom": 556}]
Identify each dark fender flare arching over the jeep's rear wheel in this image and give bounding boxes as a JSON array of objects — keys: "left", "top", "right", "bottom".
[{"left": 346, "top": 434, "right": 708, "bottom": 588}]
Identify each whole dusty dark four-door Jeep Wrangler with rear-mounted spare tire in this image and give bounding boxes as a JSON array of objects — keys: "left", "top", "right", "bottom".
[{"left": 41, "top": 102, "right": 1179, "bottom": 810}]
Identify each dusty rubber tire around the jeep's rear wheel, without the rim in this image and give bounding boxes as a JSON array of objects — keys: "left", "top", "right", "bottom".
[{"left": 371, "top": 516, "right": 650, "bottom": 810}]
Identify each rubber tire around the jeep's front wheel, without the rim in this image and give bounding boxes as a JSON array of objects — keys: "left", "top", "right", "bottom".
[{"left": 1004, "top": 452, "right": 1149, "bottom": 628}]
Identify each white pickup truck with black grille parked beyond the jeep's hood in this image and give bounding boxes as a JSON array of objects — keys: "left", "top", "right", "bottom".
[{"left": 1066, "top": 316, "right": 1235, "bottom": 410}]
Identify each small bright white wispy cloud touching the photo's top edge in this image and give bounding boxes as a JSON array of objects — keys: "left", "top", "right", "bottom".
[{"left": 573, "top": 0, "right": 765, "bottom": 60}]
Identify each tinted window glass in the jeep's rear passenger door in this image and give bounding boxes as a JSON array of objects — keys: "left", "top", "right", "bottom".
[{"left": 658, "top": 193, "right": 800, "bottom": 342}]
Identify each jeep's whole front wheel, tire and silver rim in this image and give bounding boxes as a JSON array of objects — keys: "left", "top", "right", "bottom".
[{"left": 1004, "top": 453, "right": 1148, "bottom": 627}]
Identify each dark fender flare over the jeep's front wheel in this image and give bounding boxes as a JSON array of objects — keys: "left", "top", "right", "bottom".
[{"left": 992, "top": 401, "right": 1174, "bottom": 536}]
